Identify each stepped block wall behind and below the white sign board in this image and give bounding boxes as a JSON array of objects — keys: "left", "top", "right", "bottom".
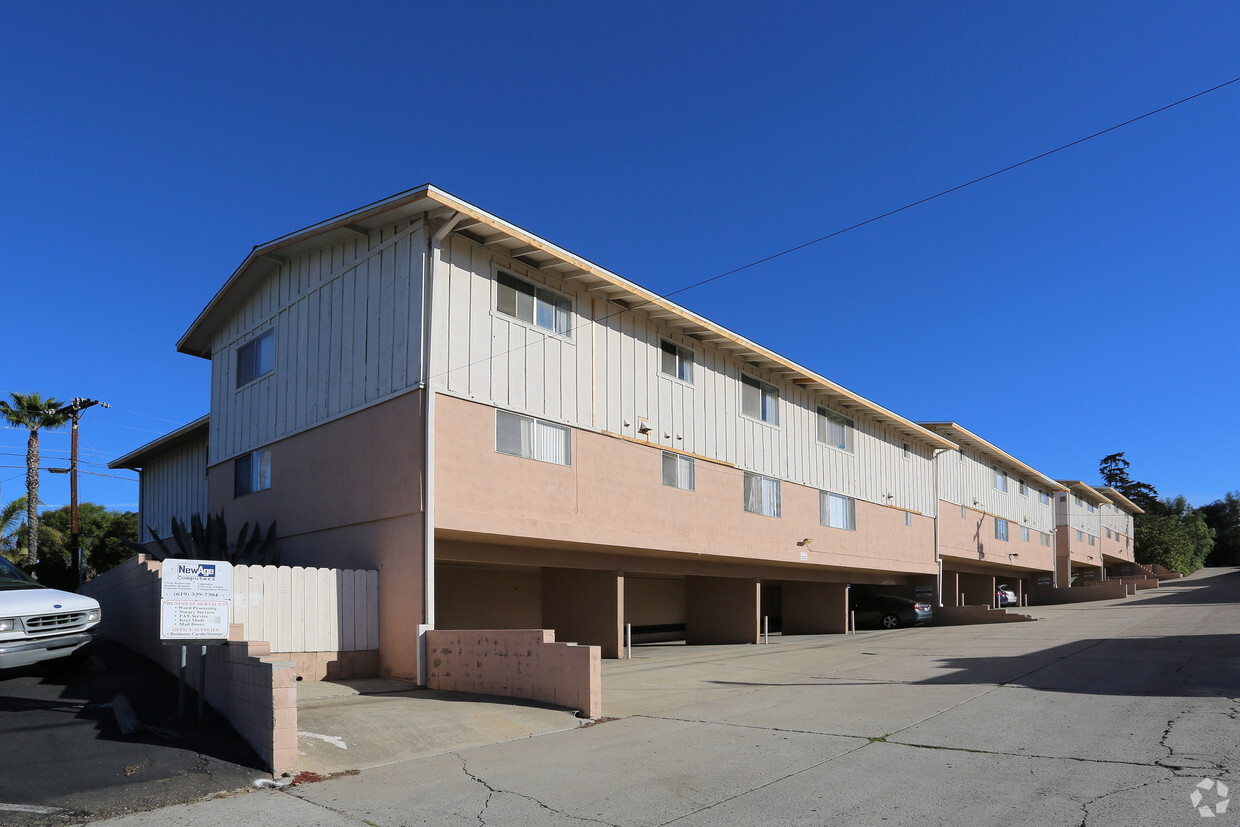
[{"left": 82, "top": 554, "right": 298, "bottom": 775}]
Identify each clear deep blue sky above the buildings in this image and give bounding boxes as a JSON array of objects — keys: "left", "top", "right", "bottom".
[{"left": 0, "top": 1, "right": 1240, "bottom": 508}]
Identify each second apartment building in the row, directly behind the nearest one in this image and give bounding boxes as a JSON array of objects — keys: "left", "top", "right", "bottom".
[{"left": 920, "top": 422, "right": 1066, "bottom": 606}]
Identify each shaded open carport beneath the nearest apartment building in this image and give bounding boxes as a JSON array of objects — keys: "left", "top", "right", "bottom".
[{"left": 435, "top": 538, "right": 934, "bottom": 658}]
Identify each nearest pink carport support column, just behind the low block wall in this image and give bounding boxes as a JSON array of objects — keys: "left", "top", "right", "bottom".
[{"left": 542, "top": 567, "right": 624, "bottom": 657}]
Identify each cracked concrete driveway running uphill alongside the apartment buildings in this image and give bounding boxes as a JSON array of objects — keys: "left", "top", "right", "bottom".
[{"left": 89, "top": 569, "right": 1240, "bottom": 827}]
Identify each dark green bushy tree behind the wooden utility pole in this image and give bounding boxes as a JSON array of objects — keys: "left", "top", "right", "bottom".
[{"left": 35, "top": 502, "right": 138, "bottom": 589}]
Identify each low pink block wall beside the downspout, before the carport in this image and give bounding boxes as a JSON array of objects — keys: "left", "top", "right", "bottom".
[{"left": 427, "top": 629, "right": 603, "bottom": 718}]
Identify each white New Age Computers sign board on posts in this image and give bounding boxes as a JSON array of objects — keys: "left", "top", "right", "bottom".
[{"left": 159, "top": 559, "right": 232, "bottom": 641}]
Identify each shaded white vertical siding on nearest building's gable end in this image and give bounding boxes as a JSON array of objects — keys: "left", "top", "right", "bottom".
[{"left": 210, "top": 222, "right": 427, "bottom": 464}]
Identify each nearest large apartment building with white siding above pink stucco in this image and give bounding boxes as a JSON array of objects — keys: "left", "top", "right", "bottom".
[{"left": 118, "top": 185, "right": 957, "bottom": 677}]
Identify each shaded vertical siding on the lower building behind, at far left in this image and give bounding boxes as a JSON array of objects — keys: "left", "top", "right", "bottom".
[{"left": 139, "top": 436, "right": 207, "bottom": 543}]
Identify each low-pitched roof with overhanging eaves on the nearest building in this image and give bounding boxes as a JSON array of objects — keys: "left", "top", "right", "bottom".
[{"left": 176, "top": 184, "right": 956, "bottom": 448}]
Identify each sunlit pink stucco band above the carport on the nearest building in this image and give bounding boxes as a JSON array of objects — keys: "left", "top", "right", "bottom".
[{"left": 435, "top": 396, "right": 936, "bottom": 579}]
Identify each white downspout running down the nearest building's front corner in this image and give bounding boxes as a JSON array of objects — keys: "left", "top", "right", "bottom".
[{"left": 418, "top": 212, "right": 461, "bottom": 686}]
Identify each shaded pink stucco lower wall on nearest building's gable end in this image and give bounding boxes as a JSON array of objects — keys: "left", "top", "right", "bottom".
[{"left": 207, "top": 392, "right": 424, "bottom": 678}]
